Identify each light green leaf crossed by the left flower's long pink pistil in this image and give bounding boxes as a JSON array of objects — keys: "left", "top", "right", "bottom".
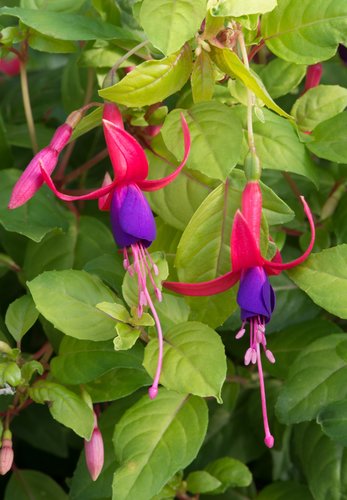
[{"left": 143, "top": 321, "right": 227, "bottom": 403}]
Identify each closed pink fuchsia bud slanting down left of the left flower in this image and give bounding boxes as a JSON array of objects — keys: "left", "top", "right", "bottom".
[{"left": 8, "top": 111, "right": 82, "bottom": 209}]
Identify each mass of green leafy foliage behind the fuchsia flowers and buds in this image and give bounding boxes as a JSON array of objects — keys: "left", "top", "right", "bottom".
[{"left": 0, "top": 0, "right": 347, "bottom": 500}]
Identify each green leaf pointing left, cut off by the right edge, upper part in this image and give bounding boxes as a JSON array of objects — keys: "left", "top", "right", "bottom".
[{"left": 307, "top": 113, "right": 347, "bottom": 163}]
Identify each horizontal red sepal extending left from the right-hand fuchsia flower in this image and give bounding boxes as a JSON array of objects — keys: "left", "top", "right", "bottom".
[{"left": 163, "top": 271, "right": 240, "bottom": 297}]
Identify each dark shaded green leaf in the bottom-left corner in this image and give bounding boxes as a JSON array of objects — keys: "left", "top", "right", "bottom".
[{"left": 4, "top": 469, "right": 68, "bottom": 500}]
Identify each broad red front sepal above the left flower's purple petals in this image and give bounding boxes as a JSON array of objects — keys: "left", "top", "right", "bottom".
[{"left": 102, "top": 119, "right": 148, "bottom": 182}]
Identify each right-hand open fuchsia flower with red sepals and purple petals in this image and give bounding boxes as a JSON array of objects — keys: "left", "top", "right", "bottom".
[{"left": 163, "top": 181, "right": 315, "bottom": 448}]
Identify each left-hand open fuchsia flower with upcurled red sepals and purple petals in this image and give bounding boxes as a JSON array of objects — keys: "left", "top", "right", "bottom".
[{"left": 41, "top": 103, "right": 190, "bottom": 399}]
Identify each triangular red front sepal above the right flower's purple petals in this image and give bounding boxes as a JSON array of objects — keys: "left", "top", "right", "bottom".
[{"left": 231, "top": 210, "right": 264, "bottom": 272}]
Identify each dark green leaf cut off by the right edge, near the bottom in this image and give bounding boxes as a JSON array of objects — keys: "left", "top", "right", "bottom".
[{"left": 317, "top": 399, "right": 347, "bottom": 446}]
